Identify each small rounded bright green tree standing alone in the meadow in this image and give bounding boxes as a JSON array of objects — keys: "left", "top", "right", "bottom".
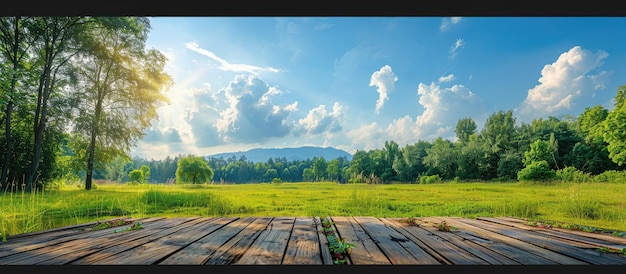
[{"left": 176, "top": 155, "right": 213, "bottom": 184}]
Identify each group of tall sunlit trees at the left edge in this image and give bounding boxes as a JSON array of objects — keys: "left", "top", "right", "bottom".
[{"left": 0, "top": 16, "right": 173, "bottom": 192}]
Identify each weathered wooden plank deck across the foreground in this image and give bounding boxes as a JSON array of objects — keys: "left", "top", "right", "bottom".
[{"left": 0, "top": 217, "right": 626, "bottom": 265}]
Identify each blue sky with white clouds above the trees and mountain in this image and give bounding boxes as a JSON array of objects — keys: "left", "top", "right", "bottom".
[{"left": 131, "top": 16, "right": 626, "bottom": 160}]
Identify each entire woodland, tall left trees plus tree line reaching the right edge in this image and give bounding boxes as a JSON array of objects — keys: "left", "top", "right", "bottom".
[{"left": 0, "top": 16, "right": 626, "bottom": 192}]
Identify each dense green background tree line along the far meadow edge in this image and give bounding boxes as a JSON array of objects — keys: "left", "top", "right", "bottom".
[{"left": 85, "top": 86, "right": 626, "bottom": 183}]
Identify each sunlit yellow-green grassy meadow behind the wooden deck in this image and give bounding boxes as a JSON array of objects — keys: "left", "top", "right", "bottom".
[{"left": 0, "top": 182, "right": 626, "bottom": 240}]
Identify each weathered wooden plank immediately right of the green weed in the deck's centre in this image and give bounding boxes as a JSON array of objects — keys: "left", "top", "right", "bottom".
[{"left": 330, "top": 217, "right": 391, "bottom": 265}]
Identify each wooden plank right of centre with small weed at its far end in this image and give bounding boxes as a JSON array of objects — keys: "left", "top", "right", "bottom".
[{"left": 420, "top": 217, "right": 560, "bottom": 265}]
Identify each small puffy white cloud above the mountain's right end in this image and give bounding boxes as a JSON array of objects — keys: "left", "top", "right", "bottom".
[{"left": 294, "top": 102, "right": 343, "bottom": 137}]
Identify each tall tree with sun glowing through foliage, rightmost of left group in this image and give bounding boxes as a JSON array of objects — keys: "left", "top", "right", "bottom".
[{"left": 73, "top": 17, "right": 172, "bottom": 190}]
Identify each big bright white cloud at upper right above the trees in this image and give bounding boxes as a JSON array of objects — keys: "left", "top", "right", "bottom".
[{"left": 517, "top": 46, "right": 610, "bottom": 121}]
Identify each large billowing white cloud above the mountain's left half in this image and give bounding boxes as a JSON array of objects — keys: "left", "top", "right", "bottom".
[{"left": 216, "top": 75, "right": 298, "bottom": 143}]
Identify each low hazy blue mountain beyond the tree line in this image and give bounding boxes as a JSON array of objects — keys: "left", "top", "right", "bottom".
[{"left": 205, "top": 146, "right": 352, "bottom": 163}]
